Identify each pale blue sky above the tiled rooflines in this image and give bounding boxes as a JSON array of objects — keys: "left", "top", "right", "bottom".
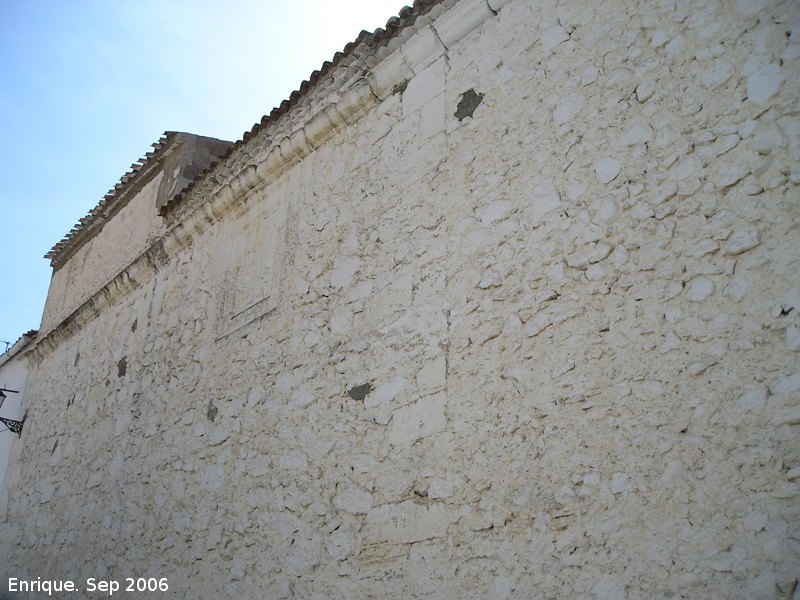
[{"left": 0, "top": 0, "right": 403, "bottom": 351}]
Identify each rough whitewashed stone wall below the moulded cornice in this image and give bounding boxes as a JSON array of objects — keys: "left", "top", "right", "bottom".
[{"left": 0, "top": 0, "right": 800, "bottom": 598}]
